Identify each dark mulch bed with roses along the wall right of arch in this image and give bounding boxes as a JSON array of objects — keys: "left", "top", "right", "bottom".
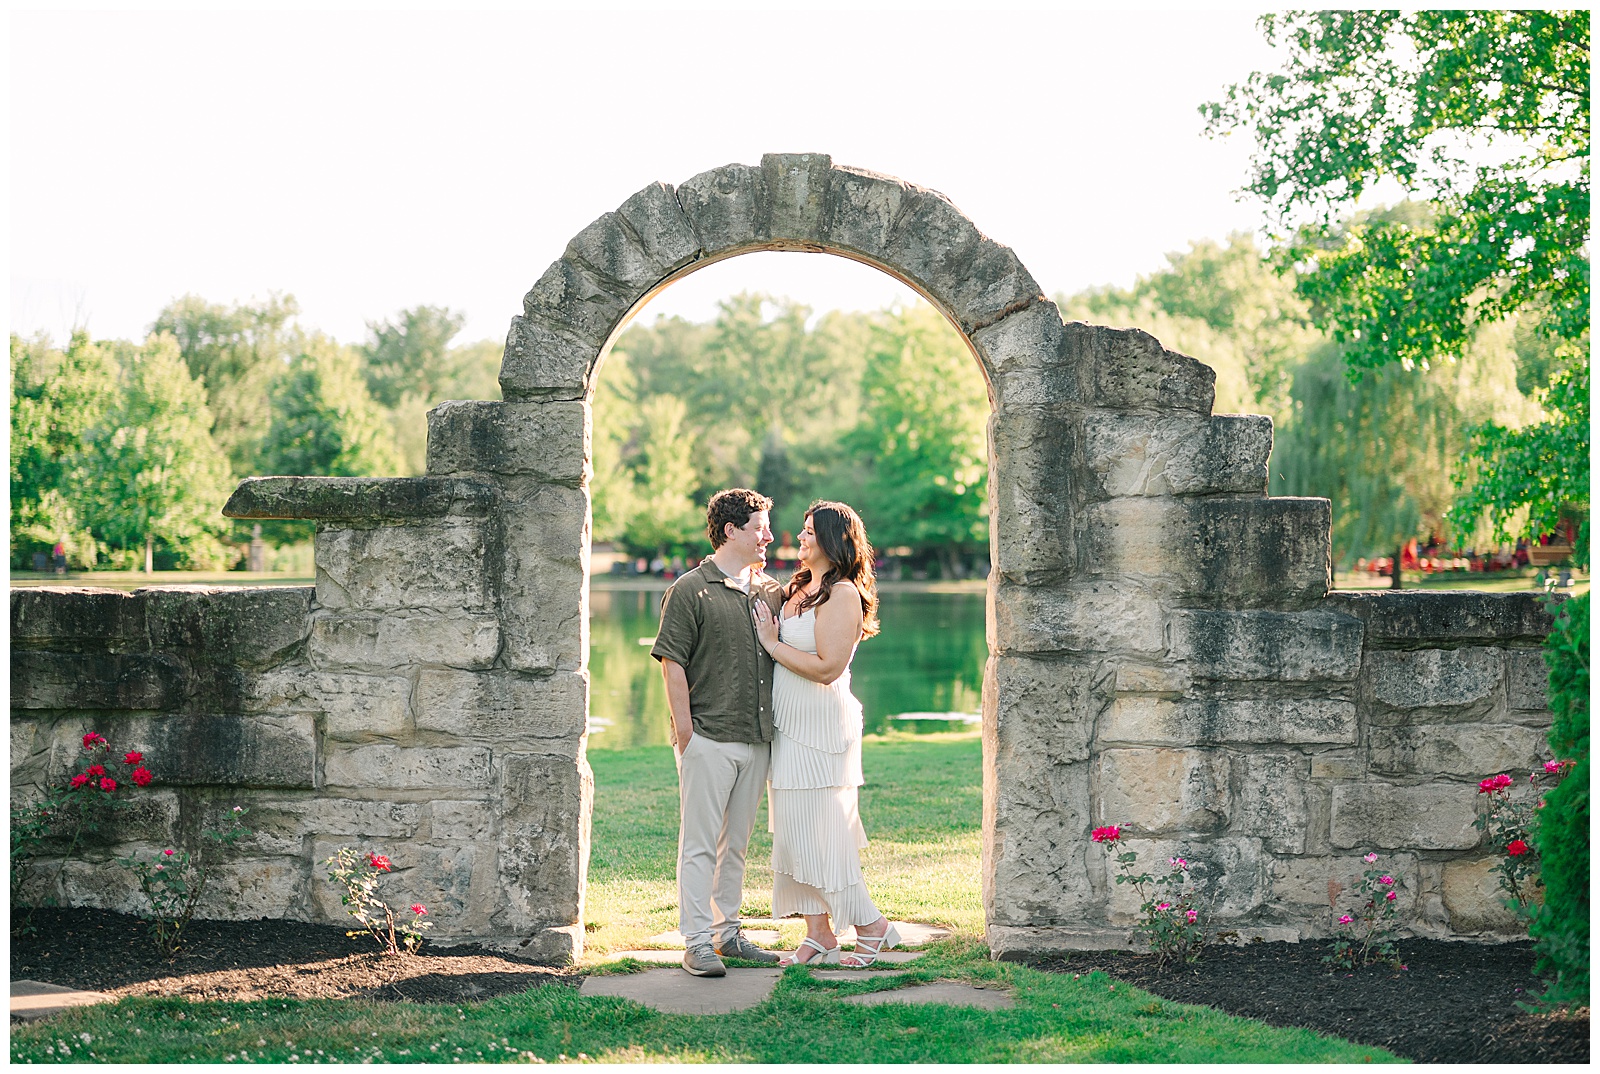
[{"left": 1029, "top": 940, "right": 1589, "bottom": 1063}]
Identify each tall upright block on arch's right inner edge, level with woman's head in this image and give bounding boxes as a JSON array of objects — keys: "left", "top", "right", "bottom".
[{"left": 989, "top": 407, "right": 1083, "bottom": 575}]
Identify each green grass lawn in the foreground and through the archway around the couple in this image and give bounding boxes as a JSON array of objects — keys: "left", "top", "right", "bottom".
[{"left": 11, "top": 733, "right": 1395, "bottom": 1063}]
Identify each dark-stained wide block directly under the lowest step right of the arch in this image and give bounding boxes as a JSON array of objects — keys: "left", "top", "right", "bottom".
[{"left": 1171, "top": 610, "right": 1362, "bottom": 682}]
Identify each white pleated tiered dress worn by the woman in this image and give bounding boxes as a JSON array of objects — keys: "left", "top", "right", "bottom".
[{"left": 766, "top": 608, "right": 878, "bottom": 928}]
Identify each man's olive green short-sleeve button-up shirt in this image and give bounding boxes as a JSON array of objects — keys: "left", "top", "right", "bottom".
[{"left": 650, "top": 557, "right": 784, "bottom": 743}]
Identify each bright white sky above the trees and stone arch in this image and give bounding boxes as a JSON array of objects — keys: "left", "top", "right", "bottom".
[{"left": 10, "top": 10, "right": 1275, "bottom": 343}]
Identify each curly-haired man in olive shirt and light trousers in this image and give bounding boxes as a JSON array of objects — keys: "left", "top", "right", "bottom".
[{"left": 650, "top": 488, "right": 782, "bottom": 976}]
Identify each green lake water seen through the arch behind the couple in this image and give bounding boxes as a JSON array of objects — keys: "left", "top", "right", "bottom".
[{"left": 589, "top": 587, "right": 989, "bottom": 749}]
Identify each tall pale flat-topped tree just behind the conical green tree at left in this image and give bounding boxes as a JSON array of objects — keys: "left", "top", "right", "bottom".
[{"left": 150, "top": 295, "right": 299, "bottom": 474}]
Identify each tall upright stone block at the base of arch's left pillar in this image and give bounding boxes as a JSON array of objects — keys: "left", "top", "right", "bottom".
[{"left": 493, "top": 754, "right": 594, "bottom": 932}]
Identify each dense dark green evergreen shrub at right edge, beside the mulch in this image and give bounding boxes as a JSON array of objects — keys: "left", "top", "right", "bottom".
[{"left": 1530, "top": 594, "right": 1589, "bottom": 1005}]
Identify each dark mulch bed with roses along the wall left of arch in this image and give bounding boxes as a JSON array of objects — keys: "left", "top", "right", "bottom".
[{"left": 11, "top": 909, "right": 579, "bottom": 1004}]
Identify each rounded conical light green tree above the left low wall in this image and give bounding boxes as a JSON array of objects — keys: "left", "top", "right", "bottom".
[{"left": 77, "top": 333, "right": 232, "bottom": 571}]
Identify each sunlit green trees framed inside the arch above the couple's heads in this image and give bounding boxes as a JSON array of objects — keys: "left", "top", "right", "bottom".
[{"left": 594, "top": 295, "right": 989, "bottom": 573}]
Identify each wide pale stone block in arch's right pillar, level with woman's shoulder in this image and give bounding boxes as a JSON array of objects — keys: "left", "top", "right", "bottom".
[{"left": 990, "top": 579, "right": 1166, "bottom": 653}]
